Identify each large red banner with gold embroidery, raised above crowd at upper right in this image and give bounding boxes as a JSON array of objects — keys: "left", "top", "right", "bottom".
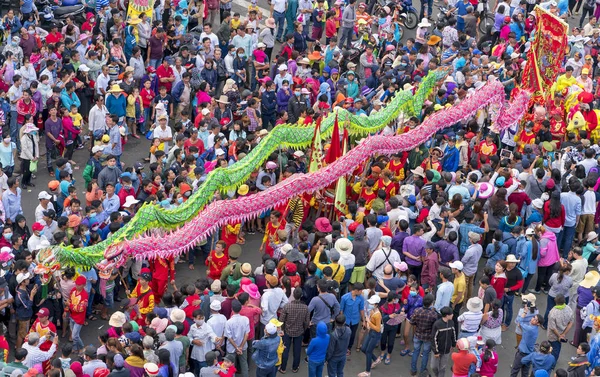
[{"left": 521, "top": 6, "right": 569, "bottom": 104}]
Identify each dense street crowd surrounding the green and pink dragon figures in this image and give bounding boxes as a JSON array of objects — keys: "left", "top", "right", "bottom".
[{"left": 0, "top": 0, "right": 600, "bottom": 377}]
